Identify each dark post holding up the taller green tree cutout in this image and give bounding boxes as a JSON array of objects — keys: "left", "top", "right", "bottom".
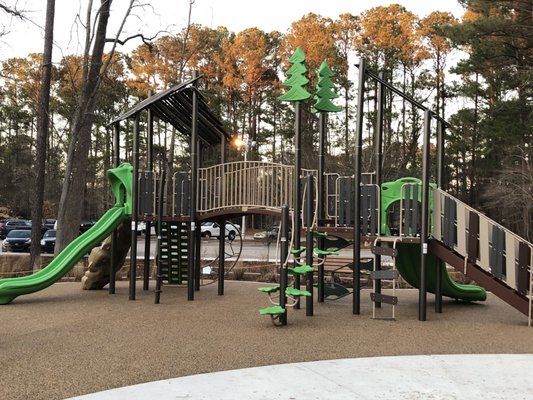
[{"left": 292, "top": 101, "right": 302, "bottom": 309}]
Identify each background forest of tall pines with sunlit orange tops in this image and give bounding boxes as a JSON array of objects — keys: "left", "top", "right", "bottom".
[{"left": 0, "top": 0, "right": 533, "bottom": 241}]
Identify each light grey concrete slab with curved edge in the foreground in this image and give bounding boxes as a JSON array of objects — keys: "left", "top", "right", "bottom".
[{"left": 72, "top": 354, "right": 533, "bottom": 400}]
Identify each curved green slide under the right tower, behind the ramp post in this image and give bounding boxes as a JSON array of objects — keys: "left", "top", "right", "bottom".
[{"left": 396, "top": 243, "right": 487, "bottom": 301}]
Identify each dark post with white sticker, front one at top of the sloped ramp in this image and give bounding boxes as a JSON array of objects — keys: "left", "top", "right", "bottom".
[{"left": 418, "top": 110, "right": 432, "bottom": 321}]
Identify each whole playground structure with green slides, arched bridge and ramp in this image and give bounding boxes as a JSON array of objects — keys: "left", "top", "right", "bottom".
[{"left": 0, "top": 59, "right": 533, "bottom": 325}]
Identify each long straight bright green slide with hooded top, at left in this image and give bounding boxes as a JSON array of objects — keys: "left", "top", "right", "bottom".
[{"left": 0, "top": 164, "right": 132, "bottom": 304}]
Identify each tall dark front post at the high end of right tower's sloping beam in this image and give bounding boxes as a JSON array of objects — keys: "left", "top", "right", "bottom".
[{"left": 352, "top": 58, "right": 366, "bottom": 315}]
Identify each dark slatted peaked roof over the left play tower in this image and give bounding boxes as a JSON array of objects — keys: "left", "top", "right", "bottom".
[{"left": 110, "top": 76, "right": 231, "bottom": 145}]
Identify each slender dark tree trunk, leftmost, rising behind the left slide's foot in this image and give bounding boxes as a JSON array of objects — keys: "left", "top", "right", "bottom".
[{"left": 30, "top": 0, "right": 55, "bottom": 268}]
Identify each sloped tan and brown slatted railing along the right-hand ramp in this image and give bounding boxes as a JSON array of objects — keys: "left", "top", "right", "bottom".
[{"left": 432, "top": 189, "right": 533, "bottom": 304}]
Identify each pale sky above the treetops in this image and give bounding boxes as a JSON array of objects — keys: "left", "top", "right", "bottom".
[{"left": 0, "top": 0, "right": 463, "bottom": 60}]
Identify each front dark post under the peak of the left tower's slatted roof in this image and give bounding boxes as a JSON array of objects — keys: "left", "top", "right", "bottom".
[{"left": 187, "top": 71, "right": 198, "bottom": 301}]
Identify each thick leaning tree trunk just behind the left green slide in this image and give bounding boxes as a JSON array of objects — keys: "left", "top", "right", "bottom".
[{"left": 55, "top": 0, "right": 111, "bottom": 254}]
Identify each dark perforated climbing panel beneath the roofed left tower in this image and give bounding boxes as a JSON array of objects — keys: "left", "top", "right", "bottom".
[{"left": 158, "top": 222, "right": 189, "bottom": 284}]
